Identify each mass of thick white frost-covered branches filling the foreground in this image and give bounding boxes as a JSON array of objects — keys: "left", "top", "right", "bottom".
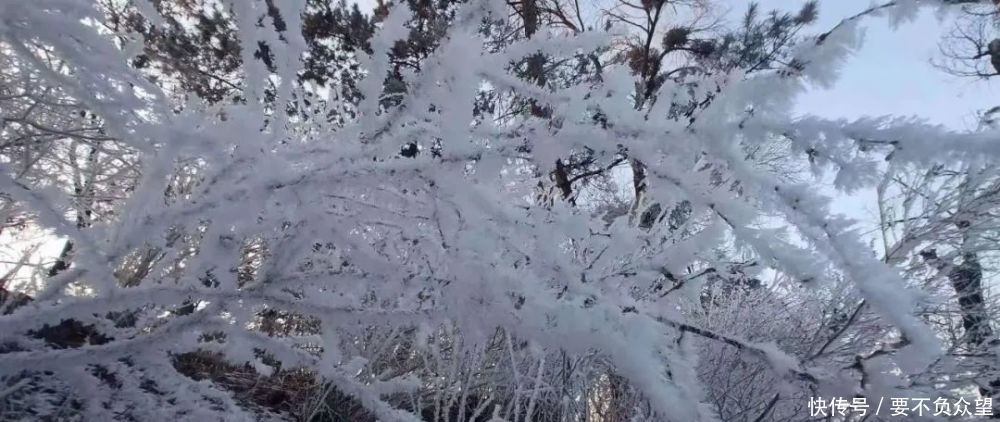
[{"left": 0, "top": 0, "right": 1000, "bottom": 422}]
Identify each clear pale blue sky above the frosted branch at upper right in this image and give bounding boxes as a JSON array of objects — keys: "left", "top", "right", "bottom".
[{"left": 752, "top": 0, "right": 1000, "bottom": 129}]
